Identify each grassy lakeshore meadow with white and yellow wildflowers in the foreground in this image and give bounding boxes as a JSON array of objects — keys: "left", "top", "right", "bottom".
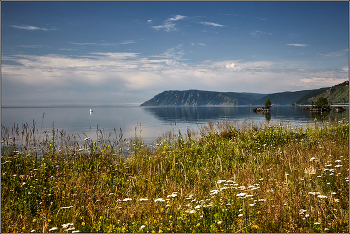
[{"left": 1, "top": 121, "right": 349, "bottom": 233}]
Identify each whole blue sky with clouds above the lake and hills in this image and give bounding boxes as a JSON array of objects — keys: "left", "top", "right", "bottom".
[{"left": 1, "top": 1, "right": 349, "bottom": 106}]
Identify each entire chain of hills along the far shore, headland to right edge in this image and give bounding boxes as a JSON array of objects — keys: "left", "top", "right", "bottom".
[{"left": 141, "top": 81, "right": 349, "bottom": 106}]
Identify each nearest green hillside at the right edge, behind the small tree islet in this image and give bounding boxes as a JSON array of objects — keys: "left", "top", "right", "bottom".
[{"left": 296, "top": 81, "right": 349, "bottom": 105}]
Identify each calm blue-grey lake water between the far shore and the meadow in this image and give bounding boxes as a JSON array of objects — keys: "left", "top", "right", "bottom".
[{"left": 1, "top": 106, "right": 349, "bottom": 144}]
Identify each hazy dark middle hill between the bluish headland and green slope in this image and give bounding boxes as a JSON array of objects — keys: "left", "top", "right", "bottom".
[{"left": 252, "top": 90, "right": 313, "bottom": 105}]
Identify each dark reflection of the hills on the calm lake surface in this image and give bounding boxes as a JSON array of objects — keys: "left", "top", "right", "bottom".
[{"left": 143, "top": 106, "right": 349, "bottom": 123}]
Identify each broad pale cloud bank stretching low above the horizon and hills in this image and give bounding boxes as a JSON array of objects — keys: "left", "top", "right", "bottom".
[{"left": 2, "top": 52, "right": 348, "bottom": 105}]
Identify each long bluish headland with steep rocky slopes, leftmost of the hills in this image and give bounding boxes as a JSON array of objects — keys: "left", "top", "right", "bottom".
[{"left": 141, "top": 90, "right": 265, "bottom": 106}]
